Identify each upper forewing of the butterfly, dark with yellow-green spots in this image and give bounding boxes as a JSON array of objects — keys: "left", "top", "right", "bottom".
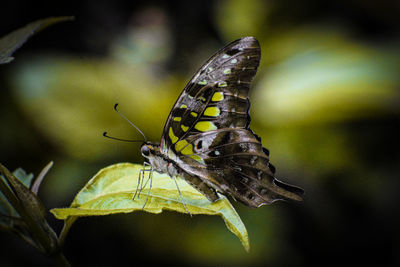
[{"left": 161, "top": 37, "right": 260, "bottom": 154}]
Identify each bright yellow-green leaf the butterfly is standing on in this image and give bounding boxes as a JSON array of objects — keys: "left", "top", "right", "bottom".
[{"left": 51, "top": 163, "right": 250, "bottom": 251}]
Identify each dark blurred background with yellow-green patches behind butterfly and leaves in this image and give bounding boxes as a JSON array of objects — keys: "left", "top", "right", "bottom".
[{"left": 0, "top": 0, "right": 400, "bottom": 266}]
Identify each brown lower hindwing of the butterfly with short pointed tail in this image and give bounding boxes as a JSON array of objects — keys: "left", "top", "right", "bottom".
[{"left": 180, "top": 129, "right": 302, "bottom": 207}]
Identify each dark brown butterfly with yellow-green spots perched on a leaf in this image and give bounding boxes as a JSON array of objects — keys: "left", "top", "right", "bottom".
[{"left": 141, "top": 37, "right": 303, "bottom": 207}]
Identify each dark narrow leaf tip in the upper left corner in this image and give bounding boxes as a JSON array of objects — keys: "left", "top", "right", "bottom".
[{"left": 0, "top": 17, "right": 73, "bottom": 64}]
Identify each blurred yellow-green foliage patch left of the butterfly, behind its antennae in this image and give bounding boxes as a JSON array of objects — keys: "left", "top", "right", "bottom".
[{"left": 10, "top": 56, "right": 181, "bottom": 161}]
